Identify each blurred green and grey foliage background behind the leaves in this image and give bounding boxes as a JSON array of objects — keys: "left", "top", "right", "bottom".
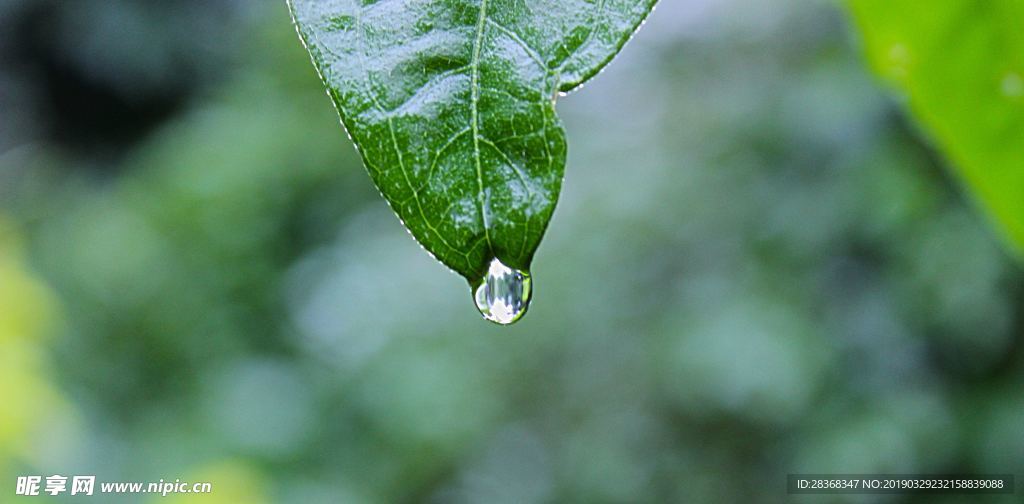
[{"left": 0, "top": 0, "right": 1024, "bottom": 503}]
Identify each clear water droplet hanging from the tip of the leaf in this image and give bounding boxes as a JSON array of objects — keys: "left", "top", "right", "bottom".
[{"left": 473, "top": 258, "right": 530, "bottom": 325}]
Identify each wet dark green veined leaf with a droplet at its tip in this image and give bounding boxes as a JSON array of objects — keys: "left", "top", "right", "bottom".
[{"left": 289, "top": 0, "right": 655, "bottom": 285}]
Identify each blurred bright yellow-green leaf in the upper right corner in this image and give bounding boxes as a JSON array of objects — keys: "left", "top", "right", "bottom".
[{"left": 849, "top": 0, "right": 1024, "bottom": 257}]
